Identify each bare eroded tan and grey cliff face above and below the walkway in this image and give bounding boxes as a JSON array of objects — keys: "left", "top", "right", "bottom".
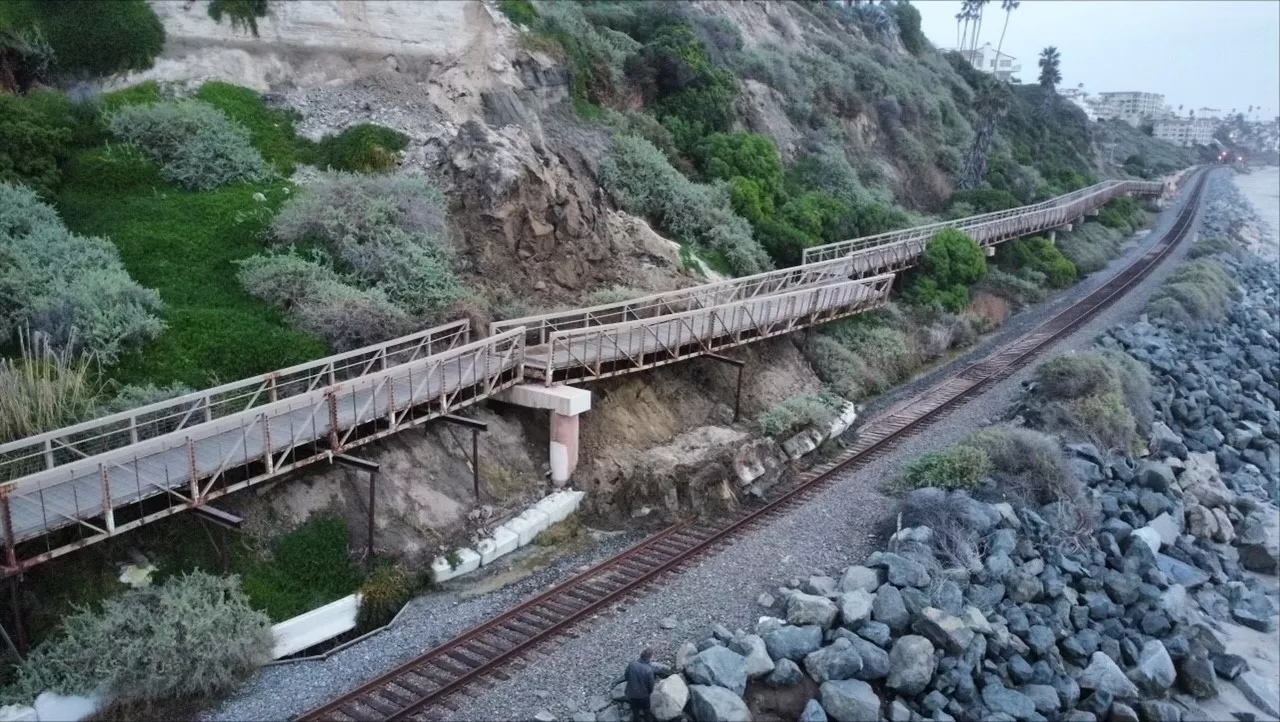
[{"left": 129, "top": 0, "right": 820, "bottom": 559}]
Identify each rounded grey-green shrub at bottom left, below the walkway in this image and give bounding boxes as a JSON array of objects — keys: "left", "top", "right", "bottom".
[{"left": 8, "top": 572, "right": 271, "bottom": 708}]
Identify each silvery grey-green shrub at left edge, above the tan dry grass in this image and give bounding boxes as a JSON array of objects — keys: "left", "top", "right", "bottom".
[{"left": 0, "top": 183, "right": 164, "bottom": 364}]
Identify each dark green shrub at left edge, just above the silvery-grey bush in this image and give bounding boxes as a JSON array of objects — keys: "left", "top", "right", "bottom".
[{"left": 0, "top": 92, "right": 72, "bottom": 197}]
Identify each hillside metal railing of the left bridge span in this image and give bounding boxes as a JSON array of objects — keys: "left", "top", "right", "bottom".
[{"left": 0, "top": 320, "right": 471, "bottom": 481}]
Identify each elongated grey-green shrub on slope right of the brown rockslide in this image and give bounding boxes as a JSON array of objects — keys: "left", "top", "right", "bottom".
[{"left": 600, "top": 136, "right": 773, "bottom": 275}]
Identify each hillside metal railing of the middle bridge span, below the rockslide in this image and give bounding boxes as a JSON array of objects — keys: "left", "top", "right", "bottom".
[{"left": 489, "top": 253, "right": 870, "bottom": 346}]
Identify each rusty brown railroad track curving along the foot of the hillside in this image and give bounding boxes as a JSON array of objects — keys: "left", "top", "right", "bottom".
[{"left": 298, "top": 170, "right": 1207, "bottom": 722}]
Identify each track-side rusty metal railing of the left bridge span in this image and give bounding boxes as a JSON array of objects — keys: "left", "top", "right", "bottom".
[{"left": 0, "top": 329, "right": 524, "bottom": 574}]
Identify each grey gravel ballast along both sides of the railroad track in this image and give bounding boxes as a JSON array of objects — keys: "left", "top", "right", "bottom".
[{"left": 205, "top": 170, "right": 1208, "bottom": 721}]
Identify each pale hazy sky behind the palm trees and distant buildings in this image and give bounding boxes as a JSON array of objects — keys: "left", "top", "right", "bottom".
[{"left": 913, "top": 0, "right": 1280, "bottom": 119}]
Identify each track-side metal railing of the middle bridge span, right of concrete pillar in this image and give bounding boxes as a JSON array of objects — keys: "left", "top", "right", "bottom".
[{"left": 526, "top": 274, "right": 893, "bottom": 385}]
